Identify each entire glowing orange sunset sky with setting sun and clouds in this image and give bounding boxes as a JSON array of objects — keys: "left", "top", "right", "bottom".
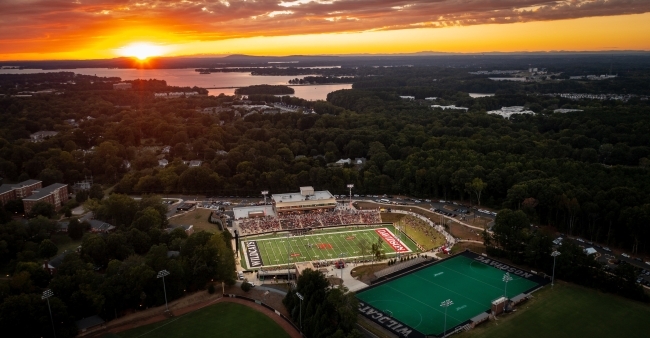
[{"left": 0, "top": 0, "right": 650, "bottom": 60}]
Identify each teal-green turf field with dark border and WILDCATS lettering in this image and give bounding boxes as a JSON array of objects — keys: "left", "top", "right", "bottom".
[{"left": 357, "top": 252, "right": 546, "bottom": 337}]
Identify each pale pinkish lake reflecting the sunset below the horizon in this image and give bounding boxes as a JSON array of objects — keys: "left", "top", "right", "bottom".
[{"left": 0, "top": 68, "right": 352, "bottom": 100}]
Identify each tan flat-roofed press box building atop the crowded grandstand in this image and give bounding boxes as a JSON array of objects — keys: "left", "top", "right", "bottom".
[{"left": 271, "top": 187, "right": 336, "bottom": 216}]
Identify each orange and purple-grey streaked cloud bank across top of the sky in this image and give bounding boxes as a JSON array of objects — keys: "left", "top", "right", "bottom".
[{"left": 0, "top": 0, "right": 650, "bottom": 58}]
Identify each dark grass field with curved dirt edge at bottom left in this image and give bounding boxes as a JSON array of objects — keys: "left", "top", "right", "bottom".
[{"left": 111, "top": 302, "right": 289, "bottom": 338}]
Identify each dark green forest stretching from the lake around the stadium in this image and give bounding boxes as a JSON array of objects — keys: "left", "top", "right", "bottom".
[{"left": 0, "top": 61, "right": 650, "bottom": 336}]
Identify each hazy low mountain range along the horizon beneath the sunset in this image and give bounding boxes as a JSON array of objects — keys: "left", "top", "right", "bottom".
[{"left": 0, "top": 50, "right": 650, "bottom": 69}]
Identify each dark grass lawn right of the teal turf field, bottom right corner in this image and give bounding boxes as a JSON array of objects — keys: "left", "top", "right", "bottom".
[{"left": 458, "top": 283, "right": 650, "bottom": 338}]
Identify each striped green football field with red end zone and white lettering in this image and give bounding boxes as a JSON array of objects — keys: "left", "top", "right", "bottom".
[{"left": 240, "top": 225, "right": 417, "bottom": 269}]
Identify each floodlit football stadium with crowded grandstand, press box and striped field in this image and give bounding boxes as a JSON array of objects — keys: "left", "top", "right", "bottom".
[{"left": 234, "top": 187, "right": 418, "bottom": 270}]
